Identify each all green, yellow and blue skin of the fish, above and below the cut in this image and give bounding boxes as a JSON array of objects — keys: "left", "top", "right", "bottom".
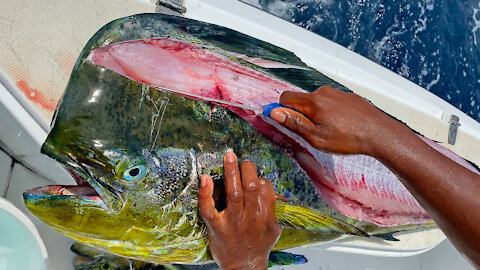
[{"left": 24, "top": 14, "right": 462, "bottom": 264}]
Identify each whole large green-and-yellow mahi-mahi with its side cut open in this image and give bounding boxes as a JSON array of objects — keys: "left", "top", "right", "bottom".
[{"left": 24, "top": 14, "right": 474, "bottom": 264}]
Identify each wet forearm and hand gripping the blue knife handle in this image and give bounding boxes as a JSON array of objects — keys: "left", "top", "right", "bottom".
[{"left": 270, "top": 86, "right": 480, "bottom": 269}]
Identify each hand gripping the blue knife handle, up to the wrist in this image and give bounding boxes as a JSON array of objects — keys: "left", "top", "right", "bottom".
[{"left": 270, "top": 86, "right": 395, "bottom": 155}]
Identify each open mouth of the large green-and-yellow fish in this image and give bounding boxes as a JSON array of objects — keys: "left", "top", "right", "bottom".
[{"left": 23, "top": 169, "right": 124, "bottom": 212}]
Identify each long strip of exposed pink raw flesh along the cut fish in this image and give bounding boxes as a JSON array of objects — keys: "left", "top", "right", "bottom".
[{"left": 87, "top": 38, "right": 475, "bottom": 226}]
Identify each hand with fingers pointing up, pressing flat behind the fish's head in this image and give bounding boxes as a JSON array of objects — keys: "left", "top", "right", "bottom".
[{"left": 198, "top": 152, "right": 281, "bottom": 269}]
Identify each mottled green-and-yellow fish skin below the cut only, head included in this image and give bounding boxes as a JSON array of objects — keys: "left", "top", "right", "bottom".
[{"left": 24, "top": 59, "right": 366, "bottom": 264}]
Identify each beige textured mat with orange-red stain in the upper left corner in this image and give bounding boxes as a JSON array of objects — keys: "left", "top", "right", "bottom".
[{"left": 0, "top": 0, "right": 155, "bottom": 127}]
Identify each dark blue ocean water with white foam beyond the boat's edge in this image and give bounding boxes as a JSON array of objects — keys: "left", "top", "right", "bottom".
[{"left": 241, "top": 0, "right": 480, "bottom": 122}]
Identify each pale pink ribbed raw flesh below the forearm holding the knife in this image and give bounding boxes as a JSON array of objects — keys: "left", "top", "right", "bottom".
[{"left": 313, "top": 136, "right": 478, "bottom": 226}]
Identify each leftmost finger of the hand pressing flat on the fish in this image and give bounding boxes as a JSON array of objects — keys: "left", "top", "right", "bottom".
[{"left": 198, "top": 175, "right": 219, "bottom": 226}]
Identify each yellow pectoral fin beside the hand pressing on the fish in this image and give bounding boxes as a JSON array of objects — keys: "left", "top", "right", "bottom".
[{"left": 275, "top": 200, "right": 369, "bottom": 237}]
